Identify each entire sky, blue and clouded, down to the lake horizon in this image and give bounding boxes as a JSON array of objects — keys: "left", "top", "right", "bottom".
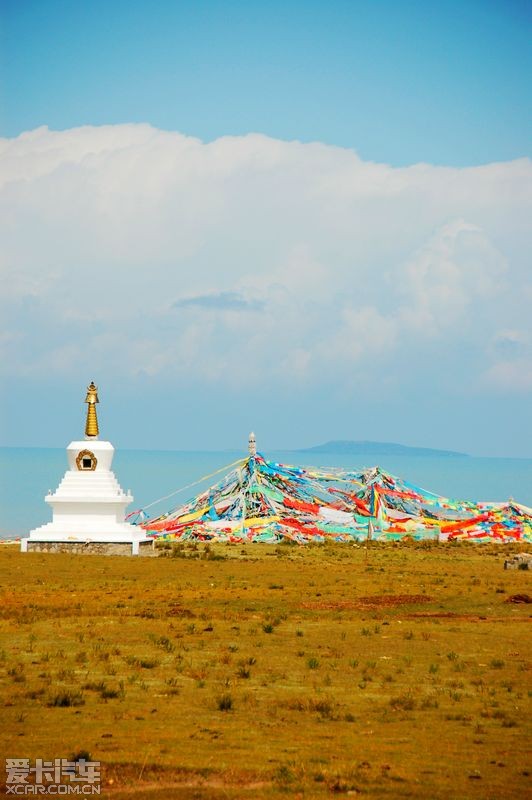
[{"left": 0, "top": 0, "right": 532, "bottom": 456}]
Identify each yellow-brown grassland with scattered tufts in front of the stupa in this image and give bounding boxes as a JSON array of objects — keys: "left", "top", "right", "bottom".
[{"left": 0, "top": 544, "right": 531, "bottom": 800}]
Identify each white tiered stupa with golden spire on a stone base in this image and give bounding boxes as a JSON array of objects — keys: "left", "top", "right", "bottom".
[{"left": 21, "top": 383, "right": 153, "bottom": 555}]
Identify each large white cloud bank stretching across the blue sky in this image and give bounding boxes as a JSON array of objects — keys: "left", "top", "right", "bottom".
[{"left": 0, "top": 125, "right": 532, "bottom": 396}]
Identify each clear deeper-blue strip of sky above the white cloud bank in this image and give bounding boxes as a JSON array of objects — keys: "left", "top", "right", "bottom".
[{"left": 1, "top": 0, "right": 532, "bottom": 166}]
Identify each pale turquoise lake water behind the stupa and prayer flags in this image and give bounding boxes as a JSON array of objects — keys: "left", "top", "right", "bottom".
[{"left": 0, "top": 447, "right": 532, "bottom": 538}]
